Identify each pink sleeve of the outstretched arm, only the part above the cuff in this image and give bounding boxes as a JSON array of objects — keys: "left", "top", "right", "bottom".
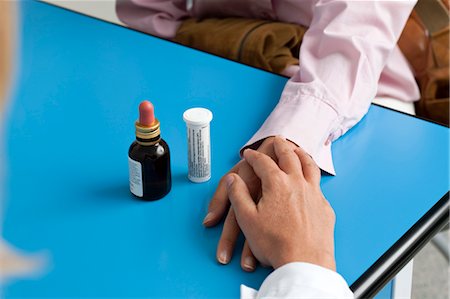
[{"left": 298, "top": 0, "right": 416, "bottom": 130}]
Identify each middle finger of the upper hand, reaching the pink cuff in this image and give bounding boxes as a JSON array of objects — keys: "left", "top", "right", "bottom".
[{"left": 273, "top": 137, "right": 302, "bottom": 174}]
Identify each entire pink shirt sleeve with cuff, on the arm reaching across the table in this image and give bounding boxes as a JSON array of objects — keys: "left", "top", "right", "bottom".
[{"left": 244, "top": 0, "right": 416, "bottom": 174}]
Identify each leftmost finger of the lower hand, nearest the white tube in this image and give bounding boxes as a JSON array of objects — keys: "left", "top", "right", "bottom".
[{"left": 203, "top": 176, "right": 230, "bottom": 227}]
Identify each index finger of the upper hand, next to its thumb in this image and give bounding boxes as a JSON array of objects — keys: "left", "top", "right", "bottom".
[{"left": 244, "top": 149, "right": 280, "bottom": 185}]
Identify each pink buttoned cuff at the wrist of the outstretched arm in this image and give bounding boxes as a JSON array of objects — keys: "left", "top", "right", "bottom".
[{"left": 241, "top": 80, "right": 339, "bottom": 175}]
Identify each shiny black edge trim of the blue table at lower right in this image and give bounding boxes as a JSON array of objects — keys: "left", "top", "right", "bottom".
[{"left": 350, "top": 191, "right": 450, "bottom": 298}]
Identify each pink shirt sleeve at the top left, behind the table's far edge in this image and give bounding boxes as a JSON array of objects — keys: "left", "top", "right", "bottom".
[{"left": 116, "top": 0, "right": 189, "bottom": 38}]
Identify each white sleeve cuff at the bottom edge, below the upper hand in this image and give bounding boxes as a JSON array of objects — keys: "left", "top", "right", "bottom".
[{"left": 257, "top": 262, "right": 354, "bottom": 298}]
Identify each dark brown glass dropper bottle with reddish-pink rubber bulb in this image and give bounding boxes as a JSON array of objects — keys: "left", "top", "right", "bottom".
[{"left": 128, "top": 101, "right": 172, "bottom": 200}]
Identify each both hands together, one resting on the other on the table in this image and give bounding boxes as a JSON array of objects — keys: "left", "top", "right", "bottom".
[{"left": 203, "top": 137, "right": 335, "bottom": 271}]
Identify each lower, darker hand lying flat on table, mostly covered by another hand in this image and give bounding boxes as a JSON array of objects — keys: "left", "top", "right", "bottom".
[{"left": 203, "top": 137, "right": 297, "bottom": 271}]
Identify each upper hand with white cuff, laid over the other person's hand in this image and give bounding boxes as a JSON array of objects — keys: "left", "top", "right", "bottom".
[{"left": 225, "top": 138, "right": 335, "bottom": 271}]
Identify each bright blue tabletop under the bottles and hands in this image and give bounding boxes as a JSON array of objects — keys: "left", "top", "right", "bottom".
[{"left": 0, "top": 1, "right": 449, "bottom": 298}]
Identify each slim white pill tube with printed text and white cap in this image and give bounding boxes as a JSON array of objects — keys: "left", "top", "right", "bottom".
[{"left": 183, "top": 108, "right": 213, "bottom": 183}]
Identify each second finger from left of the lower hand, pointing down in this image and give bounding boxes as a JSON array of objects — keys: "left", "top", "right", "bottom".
[{"left": 216, "top": 207, "right": 241, "bottom": 264}]
